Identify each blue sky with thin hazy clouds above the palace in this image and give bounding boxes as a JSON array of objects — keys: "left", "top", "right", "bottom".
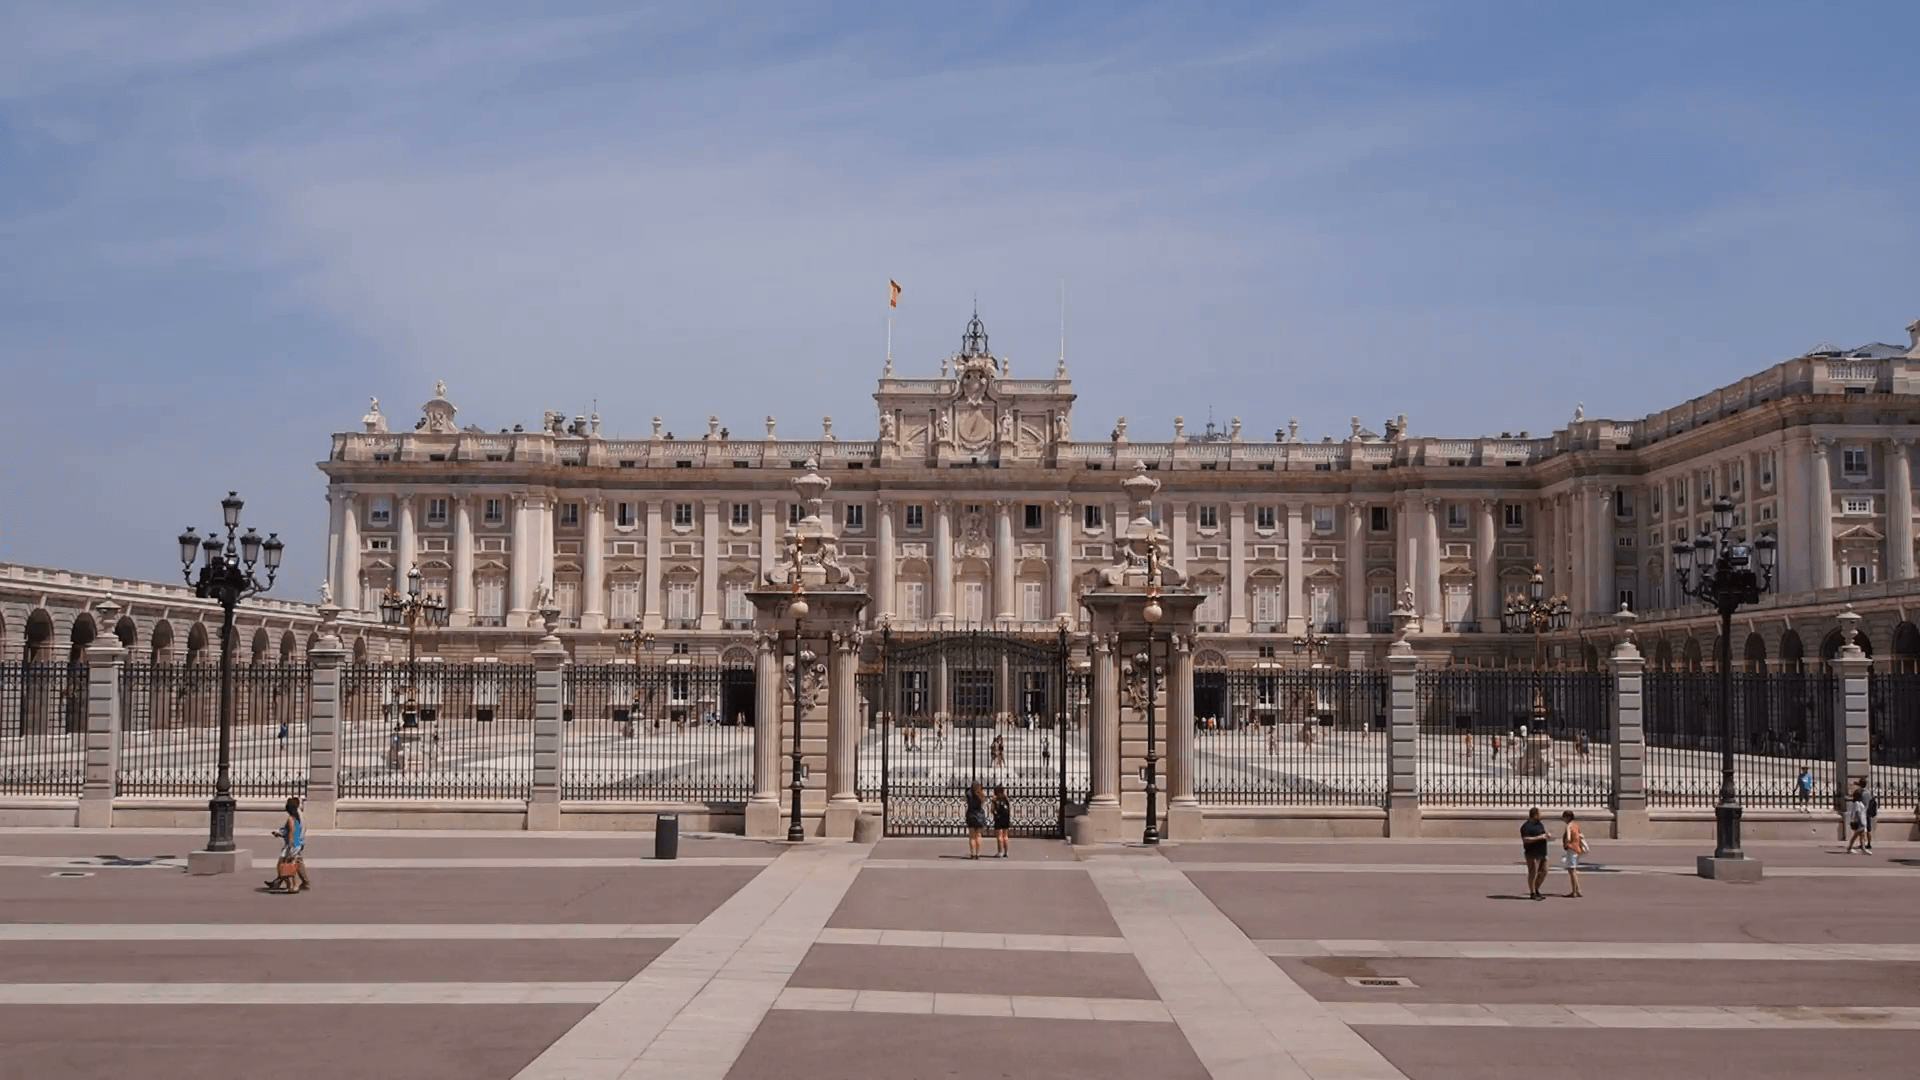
[{"left": 0, "top": 0, "right": 1920, "bottom": 598}]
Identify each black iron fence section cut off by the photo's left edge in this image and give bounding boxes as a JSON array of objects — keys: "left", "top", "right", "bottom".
[{"left": 0, "top": 663, "right": 86, "bottom": 796}]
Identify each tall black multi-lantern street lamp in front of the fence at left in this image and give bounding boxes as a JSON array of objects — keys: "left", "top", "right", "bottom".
[{"left": 180, "top": 492, "right": 286, "bottom": 851}]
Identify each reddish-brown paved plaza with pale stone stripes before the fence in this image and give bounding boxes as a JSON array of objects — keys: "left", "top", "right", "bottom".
[{"left": 0, "top": 818, "right": 1920, "bottom": 1080}]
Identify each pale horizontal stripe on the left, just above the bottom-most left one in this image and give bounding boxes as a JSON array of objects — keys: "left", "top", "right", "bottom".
[{"left": 0, "top": 922, "right": 693, "bottom": 942}]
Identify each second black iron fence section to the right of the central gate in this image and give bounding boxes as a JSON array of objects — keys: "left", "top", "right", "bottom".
[{"left": 1415, "top": 669, "right": 1613, "bottom": 807}]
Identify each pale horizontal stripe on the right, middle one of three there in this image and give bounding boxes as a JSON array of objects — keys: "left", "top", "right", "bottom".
[{"left": 1254, "top": 938, "right": 1920, "bottom": 963}]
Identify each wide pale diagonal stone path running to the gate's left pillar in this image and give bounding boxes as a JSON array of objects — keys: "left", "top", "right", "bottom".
[{"left": 516, "top": 846, "right": 868, "bottom": 1080}]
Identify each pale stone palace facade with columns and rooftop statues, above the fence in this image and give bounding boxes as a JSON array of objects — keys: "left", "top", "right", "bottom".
[{"left": 288, "top": 307, "right": 1920, "bottom": 667}]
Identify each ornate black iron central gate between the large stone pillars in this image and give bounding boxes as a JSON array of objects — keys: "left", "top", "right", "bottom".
[{"left": 866, "top": 630, "right": 1087, "bottom": 838}]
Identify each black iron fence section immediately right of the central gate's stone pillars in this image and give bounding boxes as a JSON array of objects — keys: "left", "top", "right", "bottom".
[{"left": 1194, "top": 669, "right": 1388, "bottom": 805}]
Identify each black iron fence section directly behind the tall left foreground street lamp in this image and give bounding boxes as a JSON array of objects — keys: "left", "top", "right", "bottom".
[{"left": 115, "top": 663, "right": 313, "bottom": 798}]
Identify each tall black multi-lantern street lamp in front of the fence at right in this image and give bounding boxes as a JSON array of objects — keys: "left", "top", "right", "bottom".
[{"left": 1672, "top": 496, "right": 1778, "bottom": 859}]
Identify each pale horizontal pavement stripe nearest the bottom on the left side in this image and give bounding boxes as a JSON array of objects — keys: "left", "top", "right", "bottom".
[{"left": 0, "top": 982, "right": 622, "bottom": 1005}]
